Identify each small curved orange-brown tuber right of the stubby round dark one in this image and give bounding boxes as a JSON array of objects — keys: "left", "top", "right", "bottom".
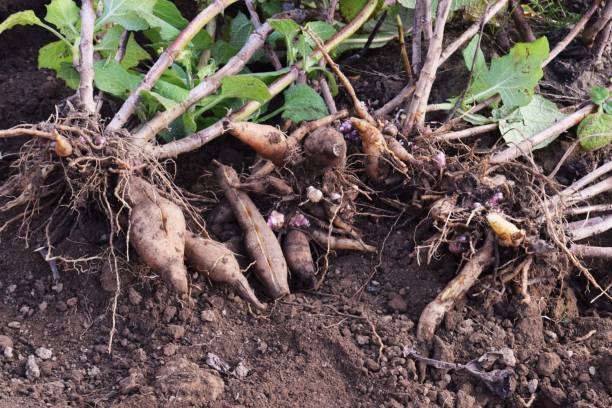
[{"left": 351, "top": 118, "right": 389, "bottom": 183}]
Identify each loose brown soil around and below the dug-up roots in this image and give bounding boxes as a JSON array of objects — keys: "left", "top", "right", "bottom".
[{"left": 0, "top": 1, "right": 612, "bottom": 408}]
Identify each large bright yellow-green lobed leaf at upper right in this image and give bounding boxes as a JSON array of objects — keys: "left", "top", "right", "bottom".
[{"left": 466, "top": 37, "right": 549, "bottom": 108}]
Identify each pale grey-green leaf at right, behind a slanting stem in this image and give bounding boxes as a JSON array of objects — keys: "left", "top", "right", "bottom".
[{"left": 499, "top": 95, "right": 565, "bottom": 149}]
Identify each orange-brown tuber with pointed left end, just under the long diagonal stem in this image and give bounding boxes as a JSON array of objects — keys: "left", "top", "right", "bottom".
[{"left": 226, "top": 122, "right": 289, "bottom": 166}]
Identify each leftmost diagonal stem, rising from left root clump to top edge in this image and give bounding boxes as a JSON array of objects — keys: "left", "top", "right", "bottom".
[{"left": 107, "top": 0, "right": 237, "bottom": 131}]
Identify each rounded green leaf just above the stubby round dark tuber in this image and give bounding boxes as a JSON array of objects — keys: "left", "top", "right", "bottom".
[{"left": 282, "top": 84, "right": 329, "bottom": 123}]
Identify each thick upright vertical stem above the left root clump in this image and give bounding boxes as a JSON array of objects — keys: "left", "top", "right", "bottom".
[{"left": 77, "top": 0, "right": 96, "bottom": 113}]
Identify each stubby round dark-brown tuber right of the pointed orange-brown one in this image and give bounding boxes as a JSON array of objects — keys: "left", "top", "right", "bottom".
[{"left": 304, "top": 127, "right": 346, "bottom": 174}]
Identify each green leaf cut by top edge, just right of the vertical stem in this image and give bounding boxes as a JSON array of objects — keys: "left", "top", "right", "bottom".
[{"left": 96, "top": 0, "right": 157, "bottom": 31}]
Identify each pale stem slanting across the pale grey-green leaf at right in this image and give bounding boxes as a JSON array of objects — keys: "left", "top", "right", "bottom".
[{"left": 490, "top": 103, "right": 596, "bottom": 164}]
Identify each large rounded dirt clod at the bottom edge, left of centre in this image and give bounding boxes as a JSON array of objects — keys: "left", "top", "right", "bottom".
[{"left": 156, "top": 357, "right": 225, "bottom": 406}]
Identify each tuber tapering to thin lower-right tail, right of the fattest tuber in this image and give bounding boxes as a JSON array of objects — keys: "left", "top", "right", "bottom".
[{"left": 185, "top": 232, "right": 266, "bottom": 310}]
